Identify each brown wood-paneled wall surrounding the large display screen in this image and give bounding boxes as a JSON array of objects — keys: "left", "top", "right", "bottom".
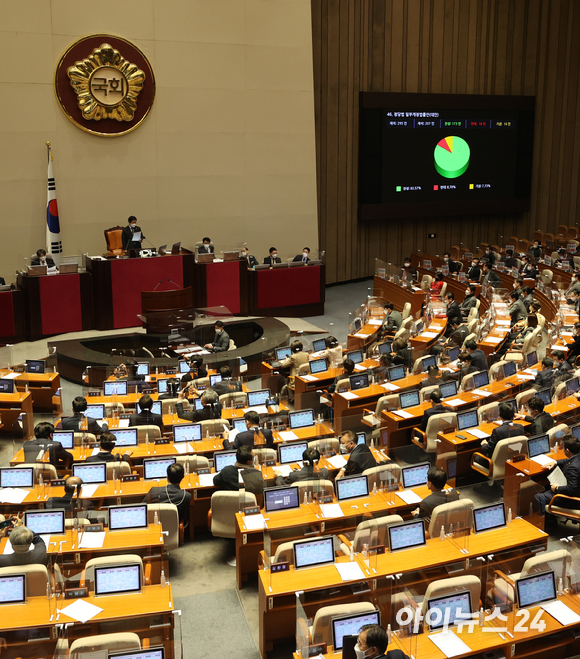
[{"left": 312, "top": 0, "right": 580, "bottom": 283}]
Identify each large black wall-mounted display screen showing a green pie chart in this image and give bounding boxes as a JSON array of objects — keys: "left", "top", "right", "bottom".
[{"left": 359, "top": 92, "right": 535, "bottom": 220}]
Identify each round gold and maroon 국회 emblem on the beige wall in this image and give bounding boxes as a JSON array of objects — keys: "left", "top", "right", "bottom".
[{"left": 55, "top": 35, "right": 155, "bottom": 137}]
